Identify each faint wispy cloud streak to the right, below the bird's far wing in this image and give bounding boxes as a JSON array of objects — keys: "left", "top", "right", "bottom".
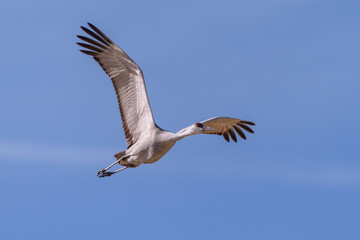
[{"left": 165, "top": 157, "right": 360, "bottom": 187}]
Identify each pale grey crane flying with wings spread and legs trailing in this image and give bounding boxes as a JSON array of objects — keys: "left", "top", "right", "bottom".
[{"left": 77, "top": 23, "right": 255, "bottom": 178}]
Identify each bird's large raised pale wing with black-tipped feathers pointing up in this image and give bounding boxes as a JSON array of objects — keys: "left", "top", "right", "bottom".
[{"left": 77, "top": 23, "right": 155, "bottom": 148}]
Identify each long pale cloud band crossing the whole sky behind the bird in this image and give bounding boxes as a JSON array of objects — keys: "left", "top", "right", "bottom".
[{"left": 0, "top": 140, "right": 360, "bottom": 186}]
